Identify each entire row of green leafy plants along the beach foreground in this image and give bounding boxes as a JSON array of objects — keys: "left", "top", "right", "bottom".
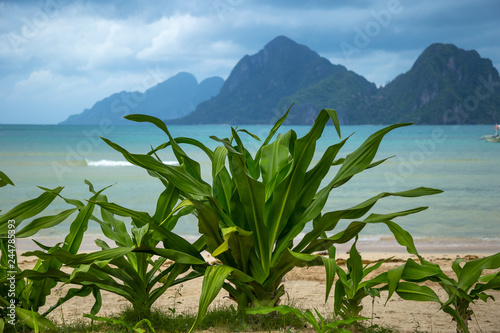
[{"left": 0, "top": 104, "right": 500, "bottom": 332}]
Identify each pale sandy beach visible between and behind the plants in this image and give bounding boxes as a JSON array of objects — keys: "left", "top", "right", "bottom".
[{"left": 12, "top": 238, "right": 500, "bottom": 333}]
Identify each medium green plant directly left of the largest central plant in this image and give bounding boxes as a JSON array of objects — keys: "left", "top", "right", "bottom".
[{"left": 25, "top": 185, "right": 205, "bottom": 315}]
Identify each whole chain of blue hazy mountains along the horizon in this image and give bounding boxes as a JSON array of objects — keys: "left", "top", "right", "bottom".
[{"left": 61, "top": 36, "right": 500, "bottom": 125}]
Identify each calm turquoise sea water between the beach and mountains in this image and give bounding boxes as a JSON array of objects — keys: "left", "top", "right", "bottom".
[{"left": 0, "top": 125, "right": 500, "bottom": 250}]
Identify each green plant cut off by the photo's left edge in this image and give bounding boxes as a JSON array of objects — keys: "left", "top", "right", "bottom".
[{"left": 0, "top": 172, "right": 98, "bottom": 331}]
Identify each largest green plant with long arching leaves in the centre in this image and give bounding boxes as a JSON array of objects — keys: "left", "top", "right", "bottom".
[{"left": 100, "top": 110, "right": 441, "bottom": 326}]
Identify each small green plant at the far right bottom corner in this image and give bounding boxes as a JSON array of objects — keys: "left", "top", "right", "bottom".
[{"left": 396, "top": 253, "right": 500, "bottom": 333}]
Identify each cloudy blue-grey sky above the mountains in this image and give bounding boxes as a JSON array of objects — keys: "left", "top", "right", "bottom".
[{"left": 0, "top": 0, "right": 500, "bottom": 124}]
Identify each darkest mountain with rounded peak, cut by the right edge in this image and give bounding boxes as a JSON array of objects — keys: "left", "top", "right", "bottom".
[{"left": 364, "top": 43, "right": 500, "bottom": 124}]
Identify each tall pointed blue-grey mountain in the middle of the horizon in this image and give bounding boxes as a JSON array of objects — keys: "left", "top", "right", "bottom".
[{"left": 170, "top": 36, "right": 376, "bottom": 124}]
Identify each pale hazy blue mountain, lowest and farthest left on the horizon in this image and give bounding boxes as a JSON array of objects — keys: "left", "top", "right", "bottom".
[{"left": 60, "top": 72, "right": 224, "bottom": 125}]
